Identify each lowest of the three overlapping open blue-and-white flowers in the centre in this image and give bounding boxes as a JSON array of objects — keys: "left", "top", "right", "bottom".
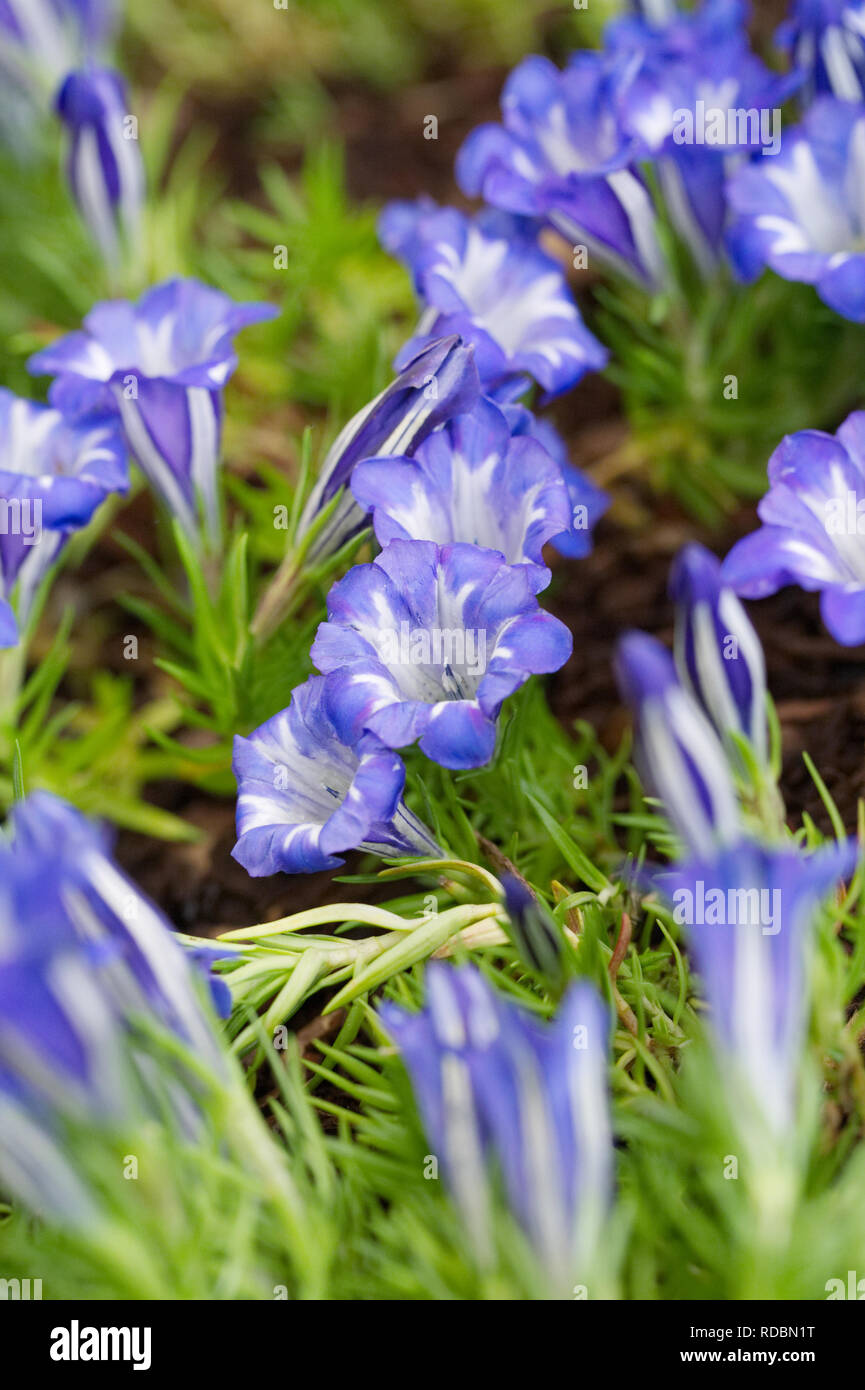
[{"left": 232, "top": 676, "right": 441, "bottom": 878}]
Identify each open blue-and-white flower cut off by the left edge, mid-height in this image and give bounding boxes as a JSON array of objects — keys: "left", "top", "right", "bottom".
[{"left": 0, "top": 389, "right": 128, "bottom": 646}]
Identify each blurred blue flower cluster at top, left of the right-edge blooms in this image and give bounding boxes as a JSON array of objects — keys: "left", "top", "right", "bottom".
[{"left": 458, "top": 0, "right": 800, "bottom": 289}]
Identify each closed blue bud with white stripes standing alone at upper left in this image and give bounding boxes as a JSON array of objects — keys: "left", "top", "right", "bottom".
[{"left": 57, "top": 68, "right": 145, "bottom": 264}]
